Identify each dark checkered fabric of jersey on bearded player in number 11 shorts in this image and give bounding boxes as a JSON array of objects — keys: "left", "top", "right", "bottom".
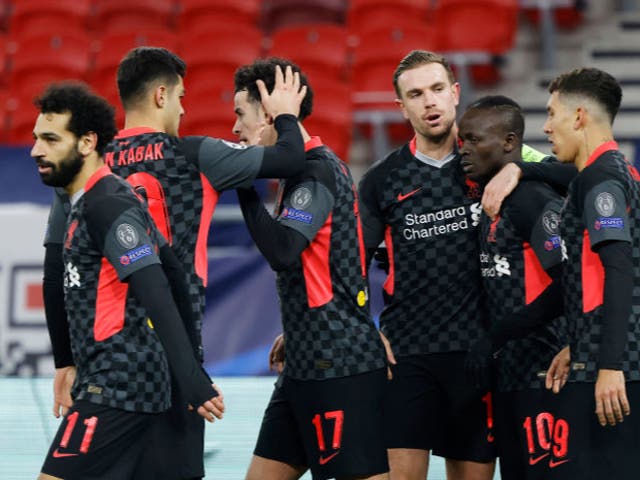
[{"left": 63, "top": 175, "right": 171, "bottom": 413}]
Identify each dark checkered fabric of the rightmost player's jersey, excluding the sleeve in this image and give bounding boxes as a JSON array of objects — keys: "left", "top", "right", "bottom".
[{"left": 561, "top": 150, "right": 640, "bottom": 382}]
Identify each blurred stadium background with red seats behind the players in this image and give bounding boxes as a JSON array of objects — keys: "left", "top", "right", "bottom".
[{"left": 0, "top": 0, "right": 640, "bottom": 479}]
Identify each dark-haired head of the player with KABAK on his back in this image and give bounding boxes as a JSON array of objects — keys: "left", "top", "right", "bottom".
[{"left": 117, "top": 47, "right": 187, "bottom": 135}]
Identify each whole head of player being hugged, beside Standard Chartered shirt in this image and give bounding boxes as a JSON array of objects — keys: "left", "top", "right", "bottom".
[{"left": 458, "top": 95, "right": 524, "bottom": 183}]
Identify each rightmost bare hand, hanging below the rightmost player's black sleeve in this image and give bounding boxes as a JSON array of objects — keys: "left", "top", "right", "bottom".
[{"left": 595, "top": 368, "right": 631, "bottom": 427}]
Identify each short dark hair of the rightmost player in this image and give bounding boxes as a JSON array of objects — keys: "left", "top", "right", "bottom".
[{"left": 549, "top": 68, "right": 622, "bottom": 124}]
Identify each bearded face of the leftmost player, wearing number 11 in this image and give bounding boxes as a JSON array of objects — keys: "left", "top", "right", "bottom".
[{"left": 31, "top": 113, "right": 84, "bottom": 187}]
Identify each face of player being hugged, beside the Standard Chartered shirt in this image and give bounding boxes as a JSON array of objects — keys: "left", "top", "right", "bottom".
[{"left": 458, "top": 109, "right": 506, "bottom": 183}]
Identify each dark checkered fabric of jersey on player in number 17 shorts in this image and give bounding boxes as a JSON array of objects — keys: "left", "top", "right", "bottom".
[{"left": 277, "top": 146, "right": 386, "bottom": 380}]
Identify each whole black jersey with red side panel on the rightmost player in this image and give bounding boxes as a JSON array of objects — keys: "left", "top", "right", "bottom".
[{"left": 560, "top": 142, "right": 640, "bottom": 382}]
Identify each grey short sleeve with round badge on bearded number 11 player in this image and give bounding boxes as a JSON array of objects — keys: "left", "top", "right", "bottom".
[{"left": 87, "top": 199, "right": 160, "bottom": 281}]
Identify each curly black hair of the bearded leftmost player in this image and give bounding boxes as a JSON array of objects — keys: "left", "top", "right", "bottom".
[{"left": 34, "top": 82, "right": 117, "bottom": 156}]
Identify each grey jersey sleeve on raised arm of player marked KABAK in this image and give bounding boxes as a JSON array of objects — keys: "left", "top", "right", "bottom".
[{"left": 198, "top": 137, "right": 264, "bottom": 192}]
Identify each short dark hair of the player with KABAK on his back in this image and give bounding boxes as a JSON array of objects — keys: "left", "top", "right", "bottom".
[{"left": 117, "top": 47, "right": 187, "bottom": 109}]
